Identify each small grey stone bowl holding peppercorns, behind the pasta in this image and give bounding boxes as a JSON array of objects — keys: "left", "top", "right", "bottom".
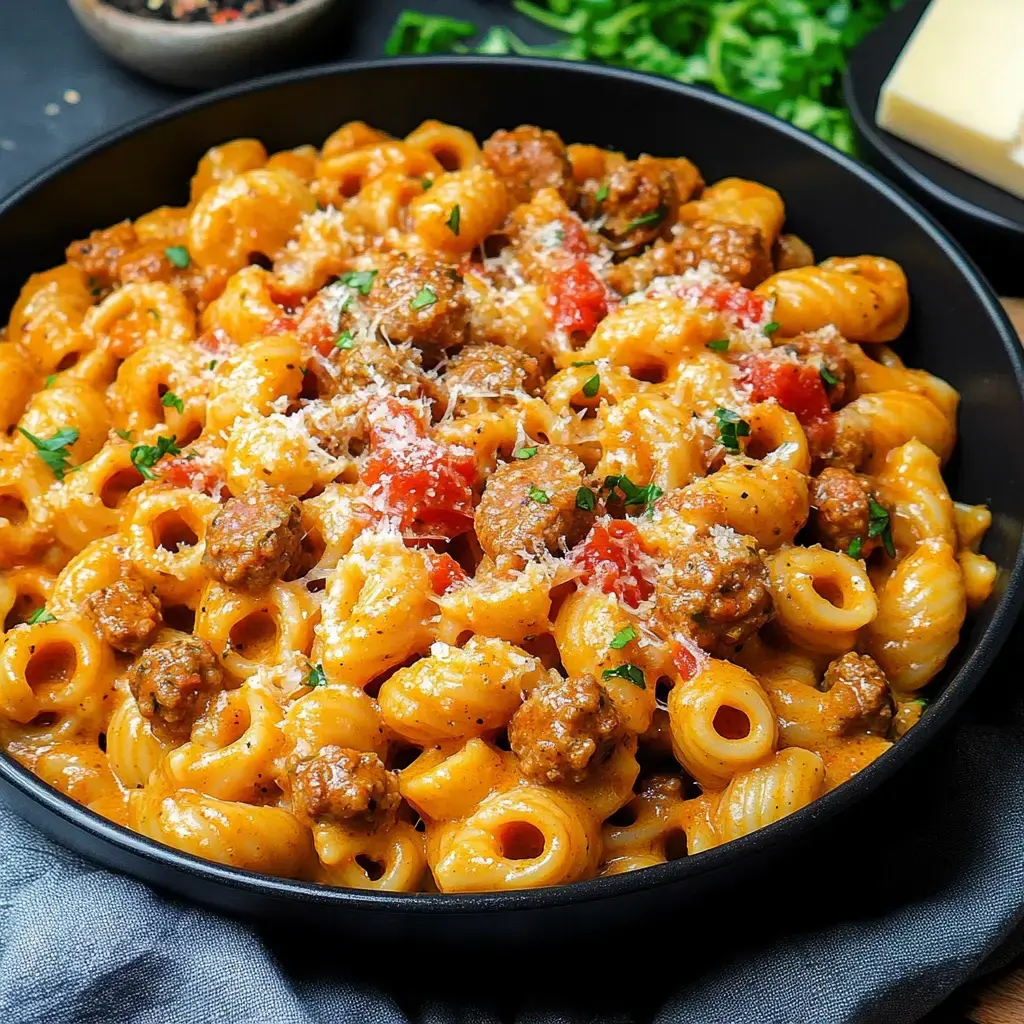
[{"left": 68, "top": 0, "right": 348, "bottom": 89}]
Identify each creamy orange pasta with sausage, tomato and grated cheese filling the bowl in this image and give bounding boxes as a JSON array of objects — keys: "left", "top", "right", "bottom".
[{"left": 0, "top": 121, "right": 999, "bottom": 893}]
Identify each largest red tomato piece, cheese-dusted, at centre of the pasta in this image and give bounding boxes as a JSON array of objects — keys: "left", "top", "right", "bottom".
[{"left": 359, "top": 398, "right": 476, "bottom": 538}]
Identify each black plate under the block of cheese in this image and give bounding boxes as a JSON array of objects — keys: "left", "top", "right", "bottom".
[{"left": 843, "top": 0, "right": 1024, "bottom": 295}]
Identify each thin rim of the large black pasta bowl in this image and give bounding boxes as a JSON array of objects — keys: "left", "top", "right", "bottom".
[{"left": 0, "top": 56, "right": 1024, "bottom": 916}]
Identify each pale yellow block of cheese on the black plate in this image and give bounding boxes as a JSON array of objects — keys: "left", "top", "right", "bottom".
[{"left": 876, "top": 0, "right": 1024, "bottom": 199}]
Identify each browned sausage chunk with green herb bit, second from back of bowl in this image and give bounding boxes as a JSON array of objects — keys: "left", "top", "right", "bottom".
[{"left": 581, "top": 157, "right": 679, "bottom": 255}]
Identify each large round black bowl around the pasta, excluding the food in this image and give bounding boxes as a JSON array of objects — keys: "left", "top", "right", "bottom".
[{"left": 0, "top": 58, "right": 1024, "bottom": 939}]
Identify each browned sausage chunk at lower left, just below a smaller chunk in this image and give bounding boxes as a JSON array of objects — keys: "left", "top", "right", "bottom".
[{"left": 128, "top": 636, "right": 223, "bottom": 743}]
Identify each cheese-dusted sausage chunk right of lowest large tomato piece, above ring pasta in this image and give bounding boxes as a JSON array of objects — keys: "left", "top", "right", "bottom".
[{"left": 654, "top": 525, "right": 772, "bottom": 656}]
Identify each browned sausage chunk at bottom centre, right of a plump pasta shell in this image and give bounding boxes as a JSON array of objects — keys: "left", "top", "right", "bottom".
[{"left": 508, "top": 673, "right": 623, "bottom": 782}]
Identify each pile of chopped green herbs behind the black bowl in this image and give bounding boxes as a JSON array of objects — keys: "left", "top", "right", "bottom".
[{"left": 386, "top": 0, "right": 903, "bottom": 153}]
